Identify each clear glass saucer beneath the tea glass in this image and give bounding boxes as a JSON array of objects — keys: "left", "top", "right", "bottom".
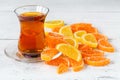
[{"left": 4, "top": 42, "right": 42, "bottom": 63}]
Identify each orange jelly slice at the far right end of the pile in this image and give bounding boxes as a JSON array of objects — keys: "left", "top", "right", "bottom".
[{"left": 98, "top": 39, "right": 114, "bottom": 52}]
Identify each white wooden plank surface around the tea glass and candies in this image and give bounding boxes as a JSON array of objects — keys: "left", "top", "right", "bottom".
[{"left": 0, "top": 0, "right": 120, "bottom": 80}]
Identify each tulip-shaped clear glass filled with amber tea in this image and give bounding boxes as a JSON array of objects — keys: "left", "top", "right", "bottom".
[{"left": 14, "top": 5, "right": 49, "bottom": 59}]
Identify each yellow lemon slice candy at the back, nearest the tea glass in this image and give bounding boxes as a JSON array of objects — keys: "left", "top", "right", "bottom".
[{"left": 44, "top": 20, "right": 64, "bottom": 29}]
